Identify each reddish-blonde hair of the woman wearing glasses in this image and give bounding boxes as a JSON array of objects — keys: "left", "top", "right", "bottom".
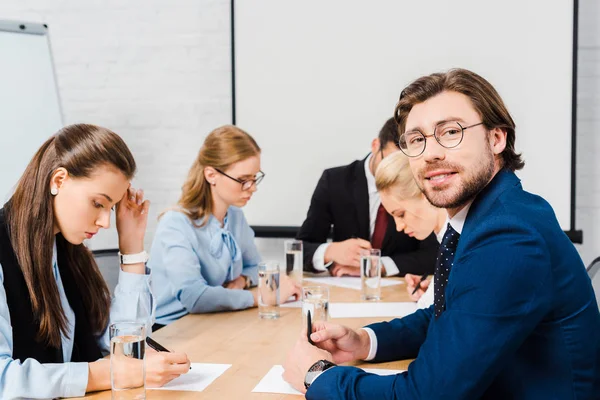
[{"left": 165, "top": 125, "right": 260, "bottom": 227}]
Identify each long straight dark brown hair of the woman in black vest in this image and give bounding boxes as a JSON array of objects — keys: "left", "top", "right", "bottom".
[{"left": 5, "top": 124, "right": 136, "bottom": 348}]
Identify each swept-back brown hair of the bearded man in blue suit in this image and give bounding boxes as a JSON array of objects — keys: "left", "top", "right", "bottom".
[{"left": 394, "top": 68, "right": 525, "bottom": 171}]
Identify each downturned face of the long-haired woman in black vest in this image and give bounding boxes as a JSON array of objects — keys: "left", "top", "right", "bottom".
[{"left": 50, "top": 166, "right": 129, "bottom": 245}]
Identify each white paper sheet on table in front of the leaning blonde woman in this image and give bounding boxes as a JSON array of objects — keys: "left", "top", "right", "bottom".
[{"left": 329, "top": 301, "right": 417, "bottom": 318}]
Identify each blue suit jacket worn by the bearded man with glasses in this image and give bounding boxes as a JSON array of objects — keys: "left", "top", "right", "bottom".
[{"left": 306, "top": 170, "right": 600, "bottom": 400}]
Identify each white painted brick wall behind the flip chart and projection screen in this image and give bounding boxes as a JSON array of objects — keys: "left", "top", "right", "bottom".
[{"left": 0, "top": 0, "right": 600, "bottom": 263}]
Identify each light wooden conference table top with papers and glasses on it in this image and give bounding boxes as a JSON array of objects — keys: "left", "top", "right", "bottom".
[{"left": 79, "top": 278, "right": 410, "bottom": 400}]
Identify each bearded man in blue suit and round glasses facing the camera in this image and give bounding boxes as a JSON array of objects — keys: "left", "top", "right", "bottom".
[{"left": 284, "top": 69, "right": 600, "bottom": 400}]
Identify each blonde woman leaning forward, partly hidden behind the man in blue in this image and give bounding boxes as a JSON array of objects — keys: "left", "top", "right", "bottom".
[{"left": 375, "top": 152, "right": 447, "bottom": 308}]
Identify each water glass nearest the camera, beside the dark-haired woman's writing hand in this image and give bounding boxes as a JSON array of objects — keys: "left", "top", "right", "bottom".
[{"left": 109, "top": 322, "right": 146, "bottom": 400}]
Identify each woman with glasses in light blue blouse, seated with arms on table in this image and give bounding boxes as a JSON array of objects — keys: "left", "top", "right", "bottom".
[{"left": 149, "top": 125, "right": 300, "bottom": 327}]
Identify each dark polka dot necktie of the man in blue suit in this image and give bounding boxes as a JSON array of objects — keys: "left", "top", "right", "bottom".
[{"left": 433, "top": 224, "right": 460, "bottom": 318}]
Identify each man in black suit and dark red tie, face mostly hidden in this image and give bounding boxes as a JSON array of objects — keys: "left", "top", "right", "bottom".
[{"left": 297, "top": 118, "right": 438, "bottom": 276}]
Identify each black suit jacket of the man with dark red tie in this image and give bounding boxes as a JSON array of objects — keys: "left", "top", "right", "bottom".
[{"left": 297, "top": 160, "right": 439, "bottom": 276}]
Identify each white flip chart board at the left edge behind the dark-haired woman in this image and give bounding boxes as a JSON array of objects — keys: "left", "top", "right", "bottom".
[{"left": 0, "top": 21, "right": 62, "bottom": 203}]
